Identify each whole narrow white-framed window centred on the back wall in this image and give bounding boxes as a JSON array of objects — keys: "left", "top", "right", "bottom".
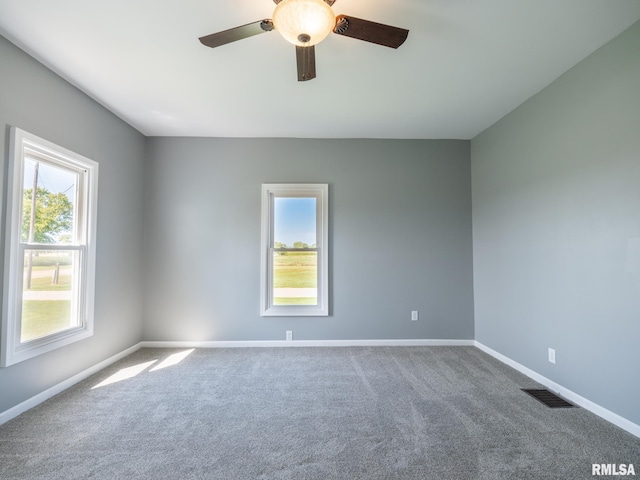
[{"left": 260, "top": 183, "right": 329, "bottom": 316}]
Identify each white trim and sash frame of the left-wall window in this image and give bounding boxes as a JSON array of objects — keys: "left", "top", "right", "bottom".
[{"left": 0, "top": 127, "right": 98, "bottom": 367}]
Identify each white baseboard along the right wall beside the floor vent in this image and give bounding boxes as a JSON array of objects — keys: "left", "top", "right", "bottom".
[{"left": 474, "top": 341, "right": 640, "bottom": 438}]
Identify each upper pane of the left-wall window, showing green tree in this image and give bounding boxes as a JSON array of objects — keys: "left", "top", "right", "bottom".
[{"left": 22, "top": 158, "right": 78, "bottom": 245}]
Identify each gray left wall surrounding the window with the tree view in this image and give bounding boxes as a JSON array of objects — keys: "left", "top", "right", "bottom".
[{"left": 0, "top": 37, "right": 145, "bottom": 412}]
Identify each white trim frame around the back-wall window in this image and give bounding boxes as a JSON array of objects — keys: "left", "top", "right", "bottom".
[{"left": 260, "top": 183, "right": 329, "bottom": 317}]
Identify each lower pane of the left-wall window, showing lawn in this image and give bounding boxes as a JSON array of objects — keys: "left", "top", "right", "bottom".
[{"left": 20, "top": 249, "right": 79, "bottom": 343}]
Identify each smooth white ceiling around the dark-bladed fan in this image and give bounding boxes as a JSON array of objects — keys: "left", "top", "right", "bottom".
[{"left": 0, "top": 0, "right": 640, "bottom": 139}]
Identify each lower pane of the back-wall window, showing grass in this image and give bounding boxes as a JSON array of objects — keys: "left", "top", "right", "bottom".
[{"left": 273, "top": 252, "right": 318, "bottom": 305}]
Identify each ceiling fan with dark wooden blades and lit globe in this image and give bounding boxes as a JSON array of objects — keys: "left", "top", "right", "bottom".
[{"left": 199, "top": 0, "right": 409, "bottom": 82}]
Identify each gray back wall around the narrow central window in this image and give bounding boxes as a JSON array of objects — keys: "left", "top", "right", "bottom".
[{"left": 143, "top": 138, "right": 474, "bottom": 340}]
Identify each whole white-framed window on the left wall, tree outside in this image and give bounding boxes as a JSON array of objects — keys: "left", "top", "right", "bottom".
[{"left": 0, "top": 128, "right": 98, "bottom": 367}]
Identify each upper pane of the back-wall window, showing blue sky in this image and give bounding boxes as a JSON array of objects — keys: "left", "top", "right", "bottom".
[{"left": 273, "top": 197, "right": 317, "bottom": 248}]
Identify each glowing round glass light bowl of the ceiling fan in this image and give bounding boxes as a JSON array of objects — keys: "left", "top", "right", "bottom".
[{"left": 273, "top": 0, "right": 336, "bottom": 47}]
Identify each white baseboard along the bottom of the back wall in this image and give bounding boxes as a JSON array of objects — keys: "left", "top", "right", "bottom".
[{"left": 139, "top": 339, "right": 475, "bottom": 348}]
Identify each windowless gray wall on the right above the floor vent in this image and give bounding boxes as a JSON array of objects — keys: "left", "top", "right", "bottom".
[{"left": 471, "top": 23, "right": 640, "bottom": 424}]
